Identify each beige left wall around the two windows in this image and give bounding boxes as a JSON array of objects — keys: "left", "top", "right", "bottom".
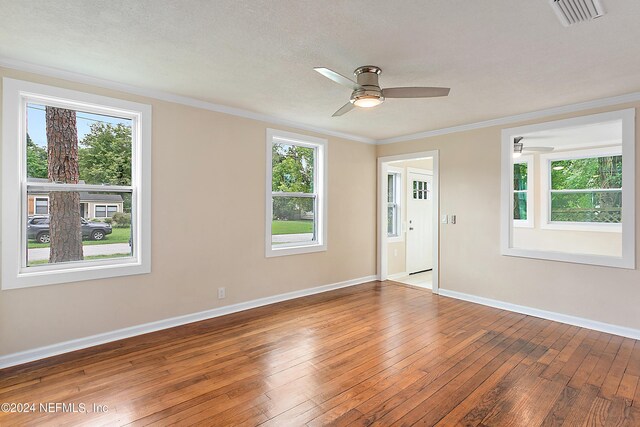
[{"left": 0, "top": 68, "right": 376, "bottom": 355}]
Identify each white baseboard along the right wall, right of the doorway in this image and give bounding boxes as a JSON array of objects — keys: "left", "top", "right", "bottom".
[{"left": 439, "top": 288, "right": 640, "bottom": 340}]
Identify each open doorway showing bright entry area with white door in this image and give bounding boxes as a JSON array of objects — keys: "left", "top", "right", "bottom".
[{"left": 378, "top": 151, "right": 439, "bottom": 293}]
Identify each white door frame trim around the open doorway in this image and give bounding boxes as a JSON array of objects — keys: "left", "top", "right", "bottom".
[{"left": 376, "top": 150, "right": 440, "bottom": 294}]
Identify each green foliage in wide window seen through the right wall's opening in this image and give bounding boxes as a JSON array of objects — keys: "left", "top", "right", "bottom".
[{"left": 551, "top": 156, "right": 622, "bottom": 223}]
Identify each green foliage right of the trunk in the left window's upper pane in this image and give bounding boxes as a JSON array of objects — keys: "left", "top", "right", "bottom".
[{"left": 78, "top": 122, "right": 131, "bottom": 185}]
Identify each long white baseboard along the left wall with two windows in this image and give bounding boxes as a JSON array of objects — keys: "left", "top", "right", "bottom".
[{"left": 0, "top": 275, "right": 377, "bottom": 369}]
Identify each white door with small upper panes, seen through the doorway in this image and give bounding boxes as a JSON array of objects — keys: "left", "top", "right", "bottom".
[{"left": 406, "top": 169, "right": 433, "bottom": 274}]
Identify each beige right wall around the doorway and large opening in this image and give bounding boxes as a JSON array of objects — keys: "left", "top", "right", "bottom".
[{"left": 378, "top": 103, "right": 640, "bottom": 329}]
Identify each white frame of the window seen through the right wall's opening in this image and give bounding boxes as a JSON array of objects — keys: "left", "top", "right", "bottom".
[{"left": 540, "top": 146, "right": 624, "bottom": 233}]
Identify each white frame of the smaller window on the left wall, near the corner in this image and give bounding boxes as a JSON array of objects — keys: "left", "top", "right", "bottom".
[{"left": 265, "top": 129, "right": 328, "bottom": 258}]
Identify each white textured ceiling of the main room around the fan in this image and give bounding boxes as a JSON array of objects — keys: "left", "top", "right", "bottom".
[{"left": 0, "top": 0, "right": 640, "bottom": 139}]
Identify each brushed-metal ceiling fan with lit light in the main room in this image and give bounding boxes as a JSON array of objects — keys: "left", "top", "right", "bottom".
[{"left": 314, "top": 65, "right": 451, "bottom": 117}]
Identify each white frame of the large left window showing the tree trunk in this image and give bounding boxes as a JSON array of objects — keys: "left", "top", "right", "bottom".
[{"left": 1, "top": 77, "right": 151, "bottom": 290}]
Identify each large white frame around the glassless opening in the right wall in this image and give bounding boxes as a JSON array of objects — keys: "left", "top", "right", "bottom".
[{"left": 500, "top": 108, "right": 636, "bottom": 269}]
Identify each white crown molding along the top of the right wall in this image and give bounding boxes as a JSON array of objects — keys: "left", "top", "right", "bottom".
[{"left": 376, "top": 92, "right": 640, "bottom": 145}]
